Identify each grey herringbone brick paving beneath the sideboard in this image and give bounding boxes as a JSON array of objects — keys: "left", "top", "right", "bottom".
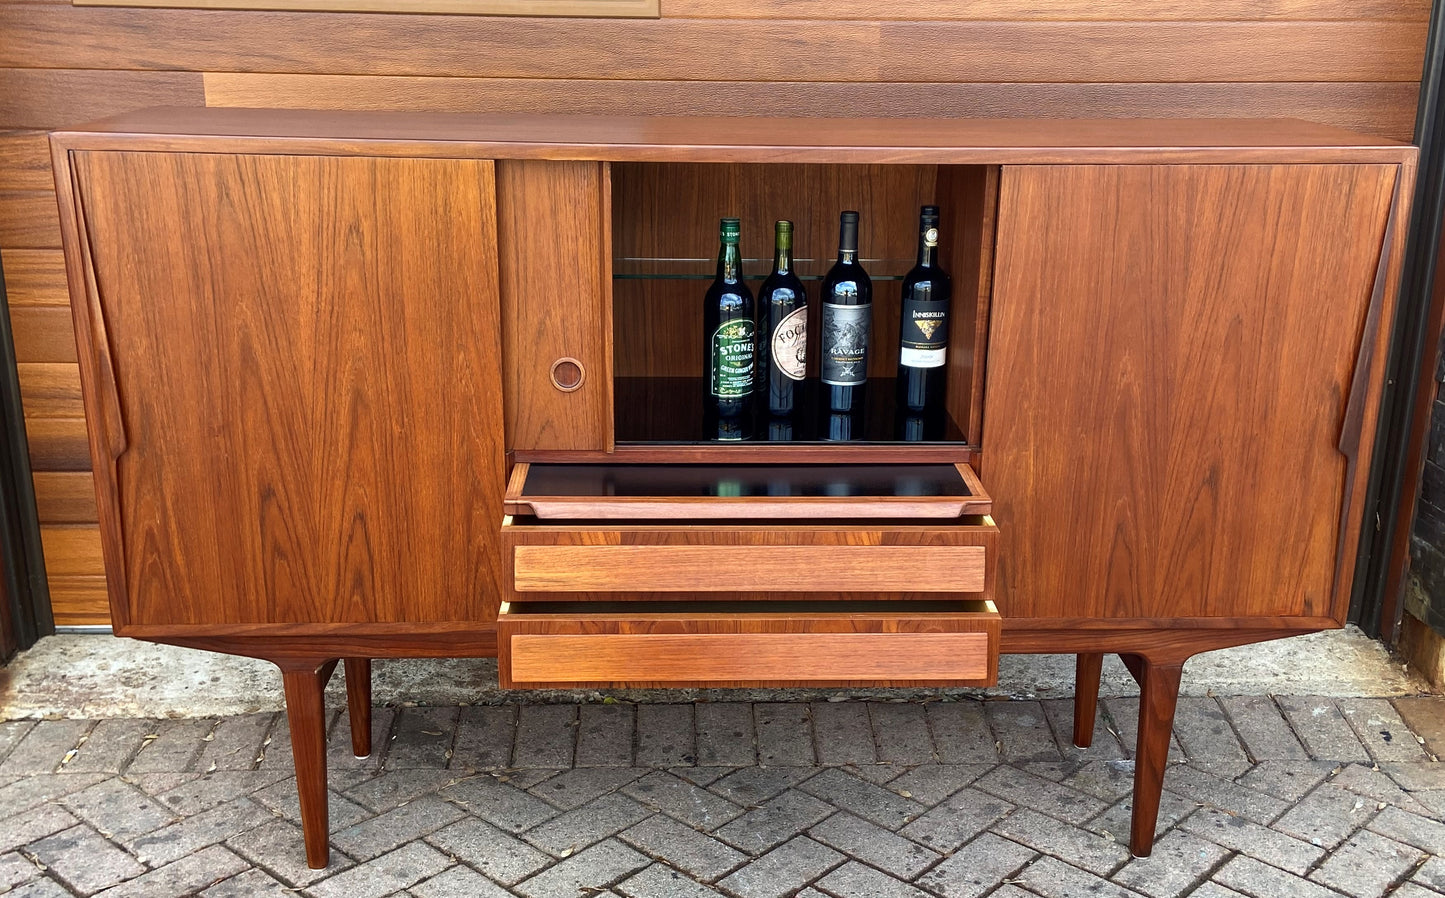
[{"left": 0, "top": 696, "right": 1445, "bottom": 898}]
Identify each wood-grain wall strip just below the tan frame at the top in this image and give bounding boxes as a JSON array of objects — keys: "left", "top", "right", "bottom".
[{"left": 0, "top": 4, "right": 1426, "bottom": 82}]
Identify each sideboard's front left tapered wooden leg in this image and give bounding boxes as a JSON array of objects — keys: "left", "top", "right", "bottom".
[{"left": 280, "top": 659, "right": 337, "bottom": 871}]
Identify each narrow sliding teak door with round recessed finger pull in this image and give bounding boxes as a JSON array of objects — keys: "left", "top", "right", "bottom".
[{"left": 497, "top": 162, "right": 613, "bottom": 450}]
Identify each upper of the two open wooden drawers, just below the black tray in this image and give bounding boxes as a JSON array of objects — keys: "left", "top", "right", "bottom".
[{"left": 503, "top": 516, "right": 998, "bottom": 599}]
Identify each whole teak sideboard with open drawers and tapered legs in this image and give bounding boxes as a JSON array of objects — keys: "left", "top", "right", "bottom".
[{"left": 51, "top": 110, "right": 1416, "bottom": 866}]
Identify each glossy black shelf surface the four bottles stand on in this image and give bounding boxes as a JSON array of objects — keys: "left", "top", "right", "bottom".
[{"left": 614, "top": 377, "right": 967, "bottom": 447}]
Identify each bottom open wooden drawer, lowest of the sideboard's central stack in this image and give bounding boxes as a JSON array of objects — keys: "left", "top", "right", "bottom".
[{"left": 497, "top": 599, "right": 998, "bottom": 688}]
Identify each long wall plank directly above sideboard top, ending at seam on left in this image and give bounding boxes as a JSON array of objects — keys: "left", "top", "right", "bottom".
[{"left": 205, "top": 72, "right": 1419, "bottom": 140}]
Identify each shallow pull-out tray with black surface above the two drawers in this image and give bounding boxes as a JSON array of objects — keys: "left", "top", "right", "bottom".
[{"left": 506, "top": 463, "right": 993, "bottom": 521}]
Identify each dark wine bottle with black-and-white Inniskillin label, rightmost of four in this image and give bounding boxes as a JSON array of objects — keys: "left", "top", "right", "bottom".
[{"left": 897, "top": 205, "right": 954, "bottom": 419}]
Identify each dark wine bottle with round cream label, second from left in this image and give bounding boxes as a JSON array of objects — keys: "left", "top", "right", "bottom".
[{"left": 757, "top": 221, "right": 808, "bottom": 418}]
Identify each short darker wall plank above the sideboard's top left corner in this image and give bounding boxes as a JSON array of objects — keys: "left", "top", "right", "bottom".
[{"left": 0, "top": 69, "right": 205, "bottom": 129}]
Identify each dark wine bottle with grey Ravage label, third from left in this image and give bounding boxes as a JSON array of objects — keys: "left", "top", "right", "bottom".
[{"left": 821, "top": 211, "right": 873, "bottom": 412}]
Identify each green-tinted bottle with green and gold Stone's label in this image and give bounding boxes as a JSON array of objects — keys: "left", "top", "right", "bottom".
[{"left": 702, "top": 218, "right": 756, "bottom": 440}]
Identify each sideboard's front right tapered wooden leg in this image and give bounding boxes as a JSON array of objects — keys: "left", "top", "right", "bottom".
[{"left": 1126, "top": 655, "right": 1183, "bottom": 858}]
